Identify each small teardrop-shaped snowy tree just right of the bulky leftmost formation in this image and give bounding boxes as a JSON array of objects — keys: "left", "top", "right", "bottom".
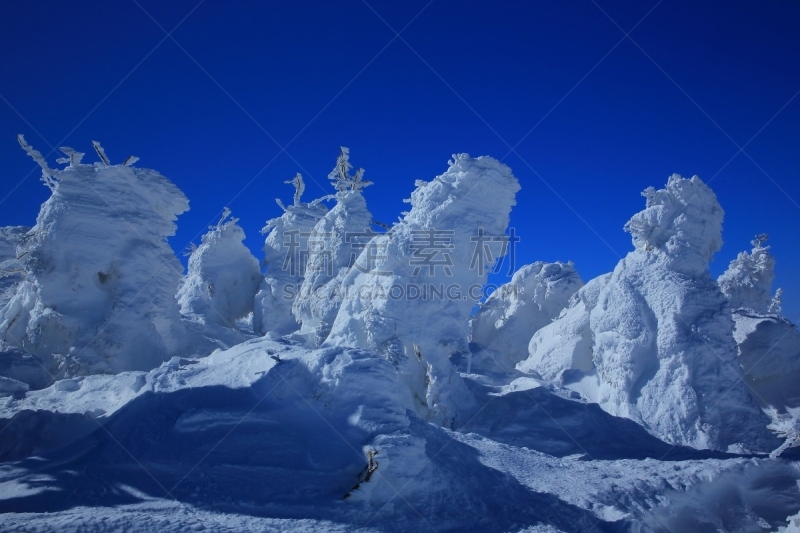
[{"left": 178, "top": 207, "right": 261, "bottom": 328}]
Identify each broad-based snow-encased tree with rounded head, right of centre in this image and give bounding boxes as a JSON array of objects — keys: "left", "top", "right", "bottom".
[{"left": 518, "top": 174, "right": 777, "bottom": 451}]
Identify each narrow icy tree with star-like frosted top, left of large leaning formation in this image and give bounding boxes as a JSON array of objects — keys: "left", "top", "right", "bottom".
[{"left": 292, "top": 147, "right": 373, "bottom": 346}]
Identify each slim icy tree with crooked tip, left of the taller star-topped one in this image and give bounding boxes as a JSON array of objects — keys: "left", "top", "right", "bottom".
[{"left": 253, "top": 174, "right": 328, "bottom": 335}]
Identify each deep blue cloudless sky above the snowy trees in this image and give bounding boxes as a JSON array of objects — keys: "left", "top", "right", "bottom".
[{"left": 0, "top": 0, "right": 800, "bottom": 321}]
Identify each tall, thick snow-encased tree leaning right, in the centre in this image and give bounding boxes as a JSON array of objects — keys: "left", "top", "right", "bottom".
[{"left": 325, "top": 154, "right": 519, "bottom": 426}]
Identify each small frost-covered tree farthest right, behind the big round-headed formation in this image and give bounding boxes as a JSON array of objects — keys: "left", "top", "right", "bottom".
[{"left": 717, "top": 234, "right": 775, "bottom": 313}]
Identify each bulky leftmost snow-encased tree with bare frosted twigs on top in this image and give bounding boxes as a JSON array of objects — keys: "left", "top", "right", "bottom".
[{"left": 0, "top": 136, "right": 189, "bottom": 377}]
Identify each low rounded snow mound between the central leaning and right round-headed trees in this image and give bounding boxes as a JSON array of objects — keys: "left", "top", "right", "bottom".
[{"left": 471, "top": 261, "right": 583, "bottom": 372}]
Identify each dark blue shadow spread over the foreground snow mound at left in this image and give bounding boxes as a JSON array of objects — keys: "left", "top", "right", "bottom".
[{"left": 0, "top": 360, "right": 625, "bottom": 532}]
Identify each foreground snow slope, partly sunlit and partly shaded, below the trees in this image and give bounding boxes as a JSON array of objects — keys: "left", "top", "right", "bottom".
[{"left": 0, "top": 339, "right": 800, "bottom": 532}]
